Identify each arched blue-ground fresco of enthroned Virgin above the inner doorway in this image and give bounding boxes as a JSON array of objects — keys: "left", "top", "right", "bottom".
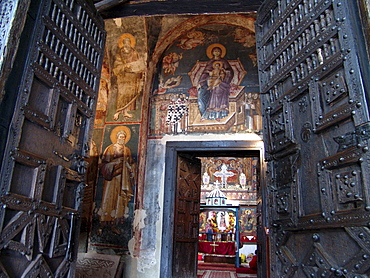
[{"left": 150, "top": 17, "right": 261, "bottom": 136}]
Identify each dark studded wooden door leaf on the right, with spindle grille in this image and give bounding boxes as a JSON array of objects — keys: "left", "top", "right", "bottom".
[{"left": 256, "top": 0, "right": 370, "bottom": 278}]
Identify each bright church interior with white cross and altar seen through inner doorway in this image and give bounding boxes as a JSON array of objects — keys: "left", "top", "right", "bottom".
[{"left": 198, "top": 156, "right": 259, "bottom": 277}]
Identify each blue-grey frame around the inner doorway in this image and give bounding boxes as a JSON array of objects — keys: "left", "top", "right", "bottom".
[{"left": 161, "top": 140, "right": 267, "bottom": 277}]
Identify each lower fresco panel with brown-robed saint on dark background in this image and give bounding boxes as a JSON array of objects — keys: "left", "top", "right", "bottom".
[{"left": 90, "top": 124, "right": 139, "bottom": 253}]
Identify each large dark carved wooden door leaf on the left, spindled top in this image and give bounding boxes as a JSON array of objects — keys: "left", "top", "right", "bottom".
[{"left": 0, "top": 0, "right": 105, "bottom": 277}]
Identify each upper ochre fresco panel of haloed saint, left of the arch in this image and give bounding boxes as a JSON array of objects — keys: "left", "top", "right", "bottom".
[{"left": 95, "top": 18, "right": 147, "bottom": 126}]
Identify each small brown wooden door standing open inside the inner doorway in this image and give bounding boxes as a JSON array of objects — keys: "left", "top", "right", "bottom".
[{"left": 172, "top": 155, "right": 201, "bottom": 278}]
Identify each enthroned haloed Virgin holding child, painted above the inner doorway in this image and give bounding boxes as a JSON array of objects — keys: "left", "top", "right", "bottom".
[{"left": 198, "top": 43, "right": 234, "bottom": 121}]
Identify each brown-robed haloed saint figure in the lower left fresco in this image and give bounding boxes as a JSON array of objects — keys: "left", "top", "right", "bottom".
[{"left": 99, "top": 126, "right": 135, "bottom": 233}]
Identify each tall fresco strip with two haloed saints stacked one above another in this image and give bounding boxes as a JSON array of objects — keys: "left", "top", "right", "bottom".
[{"left": 86, "top": 18, "right": 147, "bottom": 254}]
